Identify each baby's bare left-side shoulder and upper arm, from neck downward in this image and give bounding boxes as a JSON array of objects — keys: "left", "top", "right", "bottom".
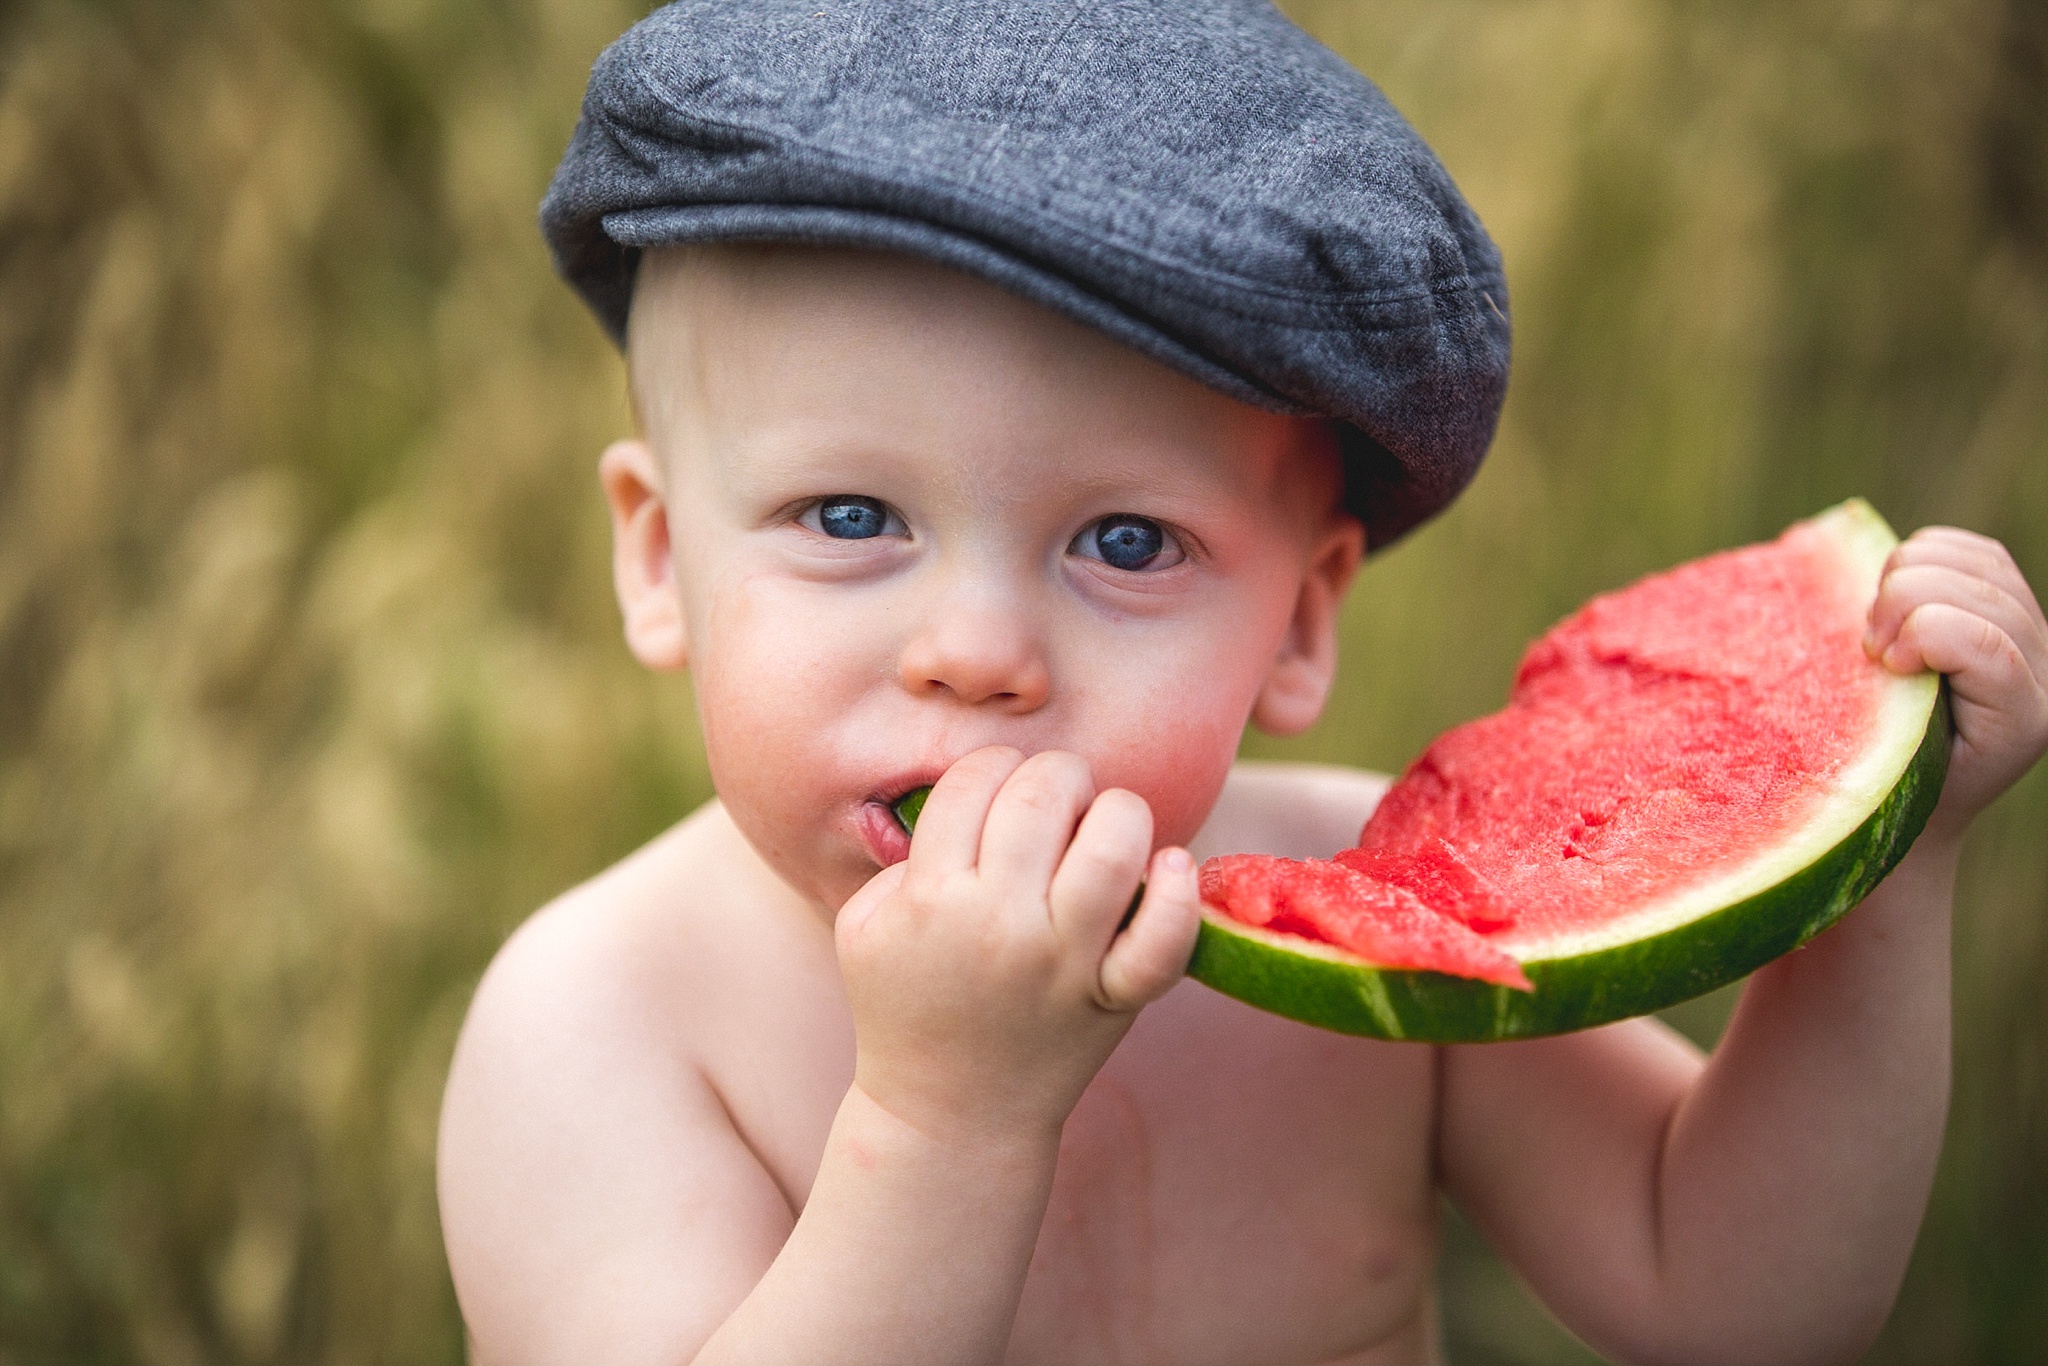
[{"left": 436, "top": 805, "right": 819, "bottom": 1362}]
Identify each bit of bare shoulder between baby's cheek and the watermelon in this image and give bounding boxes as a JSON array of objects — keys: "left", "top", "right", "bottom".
[{"left": 1190, "top": 760, "right": 1393, "bottom": 858}]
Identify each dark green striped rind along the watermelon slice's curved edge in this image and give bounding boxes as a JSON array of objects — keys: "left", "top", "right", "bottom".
[{"left": 1188, "top": 500, "right": 1952, "bottom": 1042}]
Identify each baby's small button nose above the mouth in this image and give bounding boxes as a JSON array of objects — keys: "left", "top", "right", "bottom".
[{"left": 899, "top": 586, "right": 1053, "bottom": 715}]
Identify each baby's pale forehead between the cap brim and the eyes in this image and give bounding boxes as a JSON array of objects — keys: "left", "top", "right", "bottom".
[{"left": 627, "top": 246, "right": 1335, "bottom": 507}]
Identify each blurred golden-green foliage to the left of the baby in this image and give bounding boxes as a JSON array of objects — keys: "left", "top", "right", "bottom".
[{"left": 0, "top": 0, "right": 707, "bottom": 1362}]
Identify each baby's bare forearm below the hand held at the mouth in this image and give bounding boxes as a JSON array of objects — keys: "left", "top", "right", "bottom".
[{"left": 696, "top": 1085, "right": 1059, "bottom": 1366}]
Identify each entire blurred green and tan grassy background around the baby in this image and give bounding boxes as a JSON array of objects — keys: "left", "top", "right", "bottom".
[{"left": 0, "top": 0, "right": 2048, "bottom": 1366}]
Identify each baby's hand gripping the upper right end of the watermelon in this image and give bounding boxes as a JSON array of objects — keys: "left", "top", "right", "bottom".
[{"left": 1864, "top": 526, "right": 2048, "bottom": 836}]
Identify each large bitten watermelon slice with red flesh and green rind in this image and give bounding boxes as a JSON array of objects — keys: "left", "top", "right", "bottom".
[{"left": 1188, "top": 500, "right": 1950, "bottom": 1042}]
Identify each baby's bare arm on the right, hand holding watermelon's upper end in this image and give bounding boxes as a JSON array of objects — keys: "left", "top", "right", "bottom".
[{"left": 1442, "top": 530, "right": 2048, "bottom": 1362}]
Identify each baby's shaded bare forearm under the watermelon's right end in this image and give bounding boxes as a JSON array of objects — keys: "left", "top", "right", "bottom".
[{"left": 1655, "top": 838, "right": 1956, "bottom": 1360}]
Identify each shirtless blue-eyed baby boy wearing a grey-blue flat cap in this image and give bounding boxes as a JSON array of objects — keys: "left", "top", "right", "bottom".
[{"left": 440, "top": 0, "right": 2048, "bottom": 1366}]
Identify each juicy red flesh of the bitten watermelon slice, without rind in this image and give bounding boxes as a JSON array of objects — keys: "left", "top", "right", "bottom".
[{"left": 1202, "top": 511, "right": 1888, "bottom": 981}]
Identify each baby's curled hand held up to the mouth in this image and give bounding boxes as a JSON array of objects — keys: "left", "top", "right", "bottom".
[{"left": 838, "top": 748, "right": 1200, "bottom": 1141}]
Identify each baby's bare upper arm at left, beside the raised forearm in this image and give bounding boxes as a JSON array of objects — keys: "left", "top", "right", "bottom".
[{"left": 438, "top": 897, "right": 795, "bottom": 1366}]
